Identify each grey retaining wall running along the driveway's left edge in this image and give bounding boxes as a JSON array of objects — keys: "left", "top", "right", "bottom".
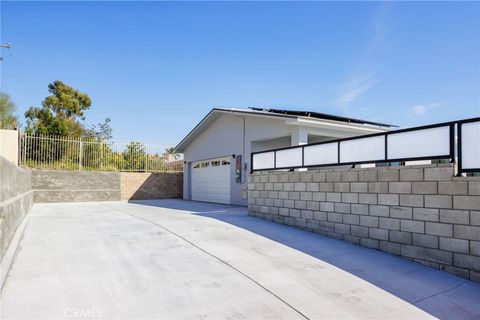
[{"left": 0, "top": 156, "right": 33, "bottom": 287}]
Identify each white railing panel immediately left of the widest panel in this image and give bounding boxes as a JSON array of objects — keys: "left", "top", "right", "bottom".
[{"left": 340, "top": 136, "right": 385, "bottom": 163}]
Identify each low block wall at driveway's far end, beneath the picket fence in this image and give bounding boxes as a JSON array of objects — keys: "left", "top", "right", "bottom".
[{"left": 32, "top": 170, "right": 183, "bottom": 202}]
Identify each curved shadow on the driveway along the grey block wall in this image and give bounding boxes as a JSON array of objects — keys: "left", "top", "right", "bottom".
[{"left": 130, "top": 200, "right": 480, "bottom": 319}]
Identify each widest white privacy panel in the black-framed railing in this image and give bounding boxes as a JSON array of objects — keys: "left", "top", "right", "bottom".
[{"left": 387, "top": 126, "right": 450, "bottom": 159}]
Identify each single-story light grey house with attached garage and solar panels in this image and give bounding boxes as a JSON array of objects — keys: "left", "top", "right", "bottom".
[{"left": 175, "top": 108, "right": 392, "bottom": 205}]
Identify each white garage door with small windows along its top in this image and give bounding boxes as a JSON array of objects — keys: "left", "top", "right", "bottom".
[{"left": 191, "top": 157, "right": 230, "bottom": 204}]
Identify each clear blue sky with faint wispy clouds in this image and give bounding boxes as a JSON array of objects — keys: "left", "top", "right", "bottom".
[{"left": 1, "top": 1, "right": 480, "bottom": 145}]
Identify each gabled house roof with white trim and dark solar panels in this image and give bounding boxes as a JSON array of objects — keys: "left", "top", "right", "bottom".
[{"left": 175, "top": 107, "right": 396, "bottom": 153}]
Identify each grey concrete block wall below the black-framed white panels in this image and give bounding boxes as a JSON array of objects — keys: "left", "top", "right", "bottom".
[{"left": 248, "top": 164, "right": 480, "bottom": 282}]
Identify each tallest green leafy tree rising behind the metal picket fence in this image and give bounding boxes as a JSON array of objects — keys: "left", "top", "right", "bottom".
[{"left": 25, "top": 80, "right": 92, "bottom": 137}]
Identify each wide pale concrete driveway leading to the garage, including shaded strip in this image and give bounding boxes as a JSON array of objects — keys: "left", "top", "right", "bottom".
[{"left": 1, "top": 200, "right": 480, "bottom": 319}]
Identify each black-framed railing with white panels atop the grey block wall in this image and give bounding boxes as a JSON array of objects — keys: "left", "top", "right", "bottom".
[{"left": 250, "top": 118, "right": 480, "bottom": 173}]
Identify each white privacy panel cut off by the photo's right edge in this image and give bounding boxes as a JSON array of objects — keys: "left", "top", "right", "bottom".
[{"left": 461, "top": 121, "right": 480, "bottom": 169}]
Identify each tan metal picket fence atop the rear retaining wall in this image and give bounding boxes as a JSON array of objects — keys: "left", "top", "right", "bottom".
[{"left": 19, "top": 133, "right": 183, "bottom": 172}]
